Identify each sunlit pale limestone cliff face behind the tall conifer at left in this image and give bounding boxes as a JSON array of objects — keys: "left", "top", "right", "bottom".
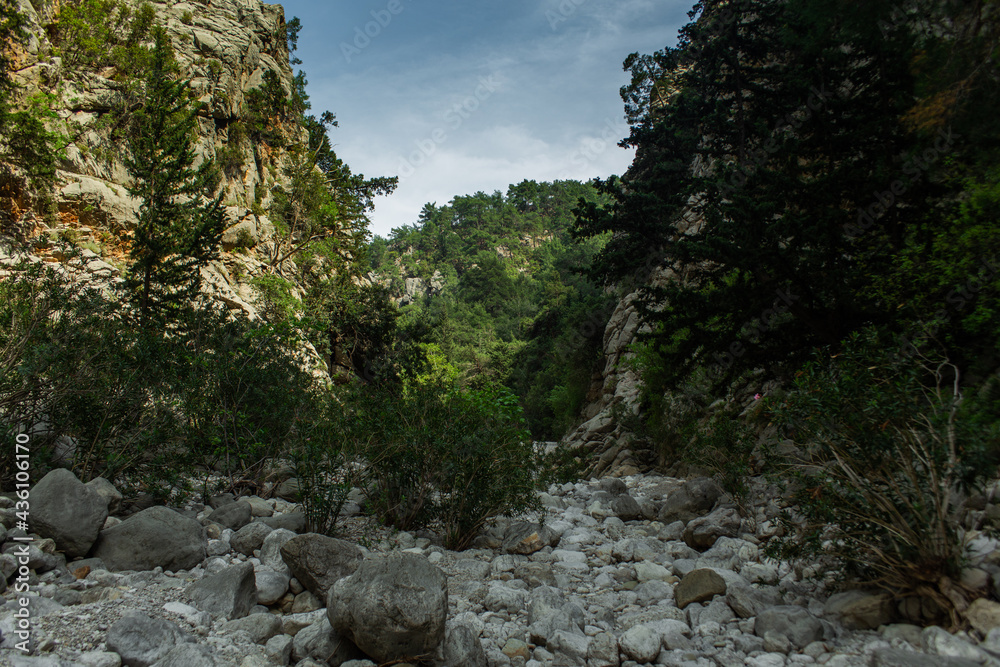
[{"left": 0, "top": 0, "right": 307, "bottom": 317}]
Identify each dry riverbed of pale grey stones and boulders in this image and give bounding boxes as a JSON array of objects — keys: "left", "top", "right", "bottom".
[{"left": 0, "top": 471, "right": 1000, "bottom": 667}]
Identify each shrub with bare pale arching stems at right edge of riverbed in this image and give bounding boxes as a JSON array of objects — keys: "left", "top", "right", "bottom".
[{"left": 770, "top": 331, "right": 996, "bottom": 622}]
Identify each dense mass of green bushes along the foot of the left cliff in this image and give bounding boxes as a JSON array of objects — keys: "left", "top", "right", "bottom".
[{"left": 0, "top": 258, "right": 336, "bottom": 504}]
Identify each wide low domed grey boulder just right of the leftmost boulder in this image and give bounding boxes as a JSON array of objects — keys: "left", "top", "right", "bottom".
[{"left": 92, "top": 506, "right": 208, "bottom": 571}]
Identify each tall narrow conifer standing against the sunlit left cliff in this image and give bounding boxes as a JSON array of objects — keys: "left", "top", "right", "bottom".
[{"left": 125, "top": 29, "right": 224, "bottom": 322}]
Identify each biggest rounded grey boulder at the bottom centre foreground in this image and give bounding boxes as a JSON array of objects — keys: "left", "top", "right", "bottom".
[{"left": 327, "top": 553, "right": 448, "bottom": 662}]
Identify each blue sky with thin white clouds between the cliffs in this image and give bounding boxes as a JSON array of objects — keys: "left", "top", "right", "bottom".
[{"left": 281, "top": 0, "right": 693, "bottom": 236}]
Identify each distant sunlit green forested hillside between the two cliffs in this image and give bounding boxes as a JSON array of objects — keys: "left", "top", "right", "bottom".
[{"left": 370, "top": 181, "right": 612, "bottom": 440}]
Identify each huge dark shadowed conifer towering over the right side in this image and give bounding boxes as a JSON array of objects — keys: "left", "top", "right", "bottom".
[{"left": 577, "top": 0, "right": 931, "bottom": 383}]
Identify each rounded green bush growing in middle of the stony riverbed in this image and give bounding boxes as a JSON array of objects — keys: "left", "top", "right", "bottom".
[{"left": 351, "top": 384, "right": 538, "bottom": 549}]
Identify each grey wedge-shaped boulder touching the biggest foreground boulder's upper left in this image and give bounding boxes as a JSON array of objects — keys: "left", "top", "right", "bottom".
[{"left": 281, "top": 533, "right": 364, "bottom": 600}]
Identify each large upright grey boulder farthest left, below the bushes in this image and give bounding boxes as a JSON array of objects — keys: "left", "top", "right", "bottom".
[{"left": 29, "top": 468, "right": 108, "bottom": 558}]
